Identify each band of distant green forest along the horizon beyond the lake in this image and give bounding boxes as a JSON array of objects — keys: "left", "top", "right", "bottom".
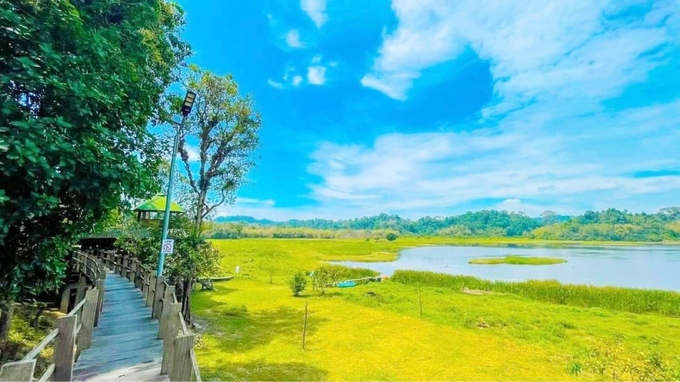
[{"left": 210, "top": 207, "right": 680, "bottom": 242}]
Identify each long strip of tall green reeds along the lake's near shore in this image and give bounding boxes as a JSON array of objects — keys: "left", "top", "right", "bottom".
[{"left": 391, "top": 270, "right": 680, "bottom": 317}]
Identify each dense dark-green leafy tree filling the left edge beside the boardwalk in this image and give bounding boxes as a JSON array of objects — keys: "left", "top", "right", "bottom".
[{"left": 0, "top": 0, "right": 190, "bottom": 340}]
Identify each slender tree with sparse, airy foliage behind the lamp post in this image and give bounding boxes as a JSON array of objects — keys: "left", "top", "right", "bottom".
[{"left": 174, "top": 66, "right": 261, "bottom": 230}]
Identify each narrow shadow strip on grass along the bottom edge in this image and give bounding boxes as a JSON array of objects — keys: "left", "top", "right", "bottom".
[{"left": 201, "top": 361, "right": 328, "bottom": 381}]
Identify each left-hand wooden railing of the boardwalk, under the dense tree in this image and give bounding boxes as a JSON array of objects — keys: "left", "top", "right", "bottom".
[{"left": 0, "top": 252, "right": 106, "bottom": 382}]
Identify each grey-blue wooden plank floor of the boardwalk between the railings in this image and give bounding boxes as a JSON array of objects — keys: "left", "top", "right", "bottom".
[{"left": 73, "top": 272, "right": 169, "bottom": 381}]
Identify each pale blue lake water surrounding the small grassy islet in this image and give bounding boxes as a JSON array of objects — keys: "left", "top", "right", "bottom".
[{"left": 337, "top": 245, "right": 680, "bottom": 292}]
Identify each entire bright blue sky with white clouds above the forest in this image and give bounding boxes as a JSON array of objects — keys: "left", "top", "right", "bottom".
[{"left": 180, "top": 0, "right": 680, "bottom": 220}]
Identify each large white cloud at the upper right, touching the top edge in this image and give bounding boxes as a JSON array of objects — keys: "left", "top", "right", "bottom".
[{"left": 361, "top": 0, "right": 680, "bottom": 106}]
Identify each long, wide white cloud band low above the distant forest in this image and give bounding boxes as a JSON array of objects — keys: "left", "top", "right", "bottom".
[{"left": 308, "top": 102, "right": 680, "bottom": 216}]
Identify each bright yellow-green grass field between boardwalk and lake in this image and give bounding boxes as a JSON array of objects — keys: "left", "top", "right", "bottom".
[{"left": 193, "top": 238, "right": 680, "bottom": 380}]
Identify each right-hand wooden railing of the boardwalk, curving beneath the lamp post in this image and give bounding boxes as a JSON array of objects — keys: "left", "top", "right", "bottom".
[{"left": 98, "top": 251, "right": 201, "bottom": 382}]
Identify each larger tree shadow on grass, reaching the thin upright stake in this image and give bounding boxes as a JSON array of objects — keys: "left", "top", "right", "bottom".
[{"left": 201, "top": 300, "right": 328, "bottom": 353}]
